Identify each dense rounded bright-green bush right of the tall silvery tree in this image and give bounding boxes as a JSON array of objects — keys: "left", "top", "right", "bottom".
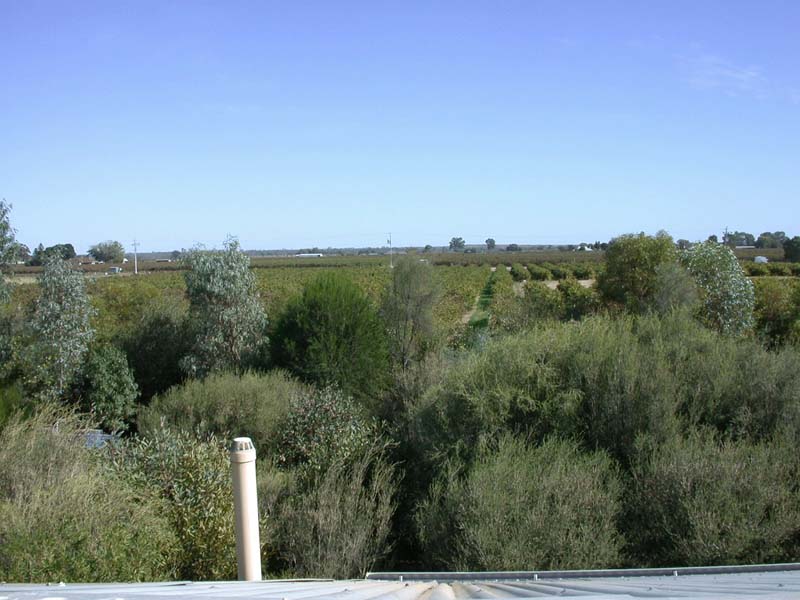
[{"left": 273, "top": 273, "right": 389, "bottom": 410}]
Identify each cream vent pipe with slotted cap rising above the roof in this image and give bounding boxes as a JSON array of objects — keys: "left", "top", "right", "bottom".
[{"left": 230, "top": 438, "right": 261, "bottom": 581}]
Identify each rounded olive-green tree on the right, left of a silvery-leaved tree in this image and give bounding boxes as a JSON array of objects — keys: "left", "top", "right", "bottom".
[{"left": 597, "top": 232, "right": 676, "bottom": 312}]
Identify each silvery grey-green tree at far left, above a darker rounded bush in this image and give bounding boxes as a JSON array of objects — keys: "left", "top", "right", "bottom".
[{"left": 20, "top": 259, "right": 94, "bottom": 401}]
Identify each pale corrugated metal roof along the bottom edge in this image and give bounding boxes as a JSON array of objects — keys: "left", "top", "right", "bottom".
[{"left": 0, "top": 565, "right": 800, "bottom": 600}]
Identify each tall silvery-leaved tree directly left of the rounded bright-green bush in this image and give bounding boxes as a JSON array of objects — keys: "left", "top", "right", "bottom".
[{"left": 183, "top": 239, "right": 267, "bottom": 376}]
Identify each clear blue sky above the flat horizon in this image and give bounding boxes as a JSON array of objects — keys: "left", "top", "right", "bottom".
[{"left": 0, "top": 0, "right": 800, "bottom": 252}]
